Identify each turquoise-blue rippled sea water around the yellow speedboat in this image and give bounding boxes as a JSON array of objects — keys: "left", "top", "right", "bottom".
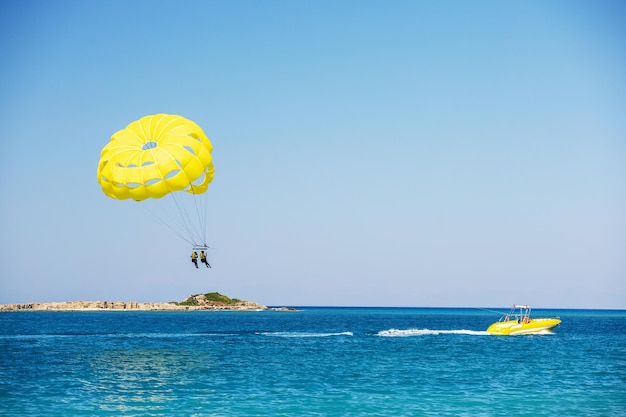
[{"left": 0, "top": 308, "right": 626, "bottom": 416}]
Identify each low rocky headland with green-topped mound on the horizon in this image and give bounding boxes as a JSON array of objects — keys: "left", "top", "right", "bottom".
[{"left": 0, "top": 292, "right": 295, "bottom": 312}]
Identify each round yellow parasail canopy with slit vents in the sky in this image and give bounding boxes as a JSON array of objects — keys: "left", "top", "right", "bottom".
[{"left": 98, "top": 114, "right": 214, "bottom": 201}]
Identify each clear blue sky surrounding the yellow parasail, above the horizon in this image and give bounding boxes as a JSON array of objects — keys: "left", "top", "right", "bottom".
[{"left": 0, "top": 0, "right": 626, "bottom": 308}]
